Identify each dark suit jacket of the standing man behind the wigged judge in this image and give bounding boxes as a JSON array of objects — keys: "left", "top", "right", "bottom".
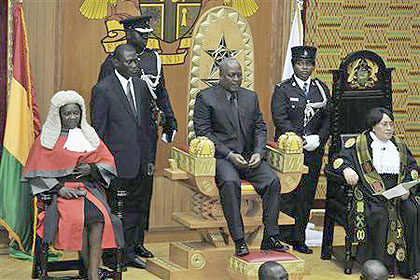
[{"left": 90, "top": 73, "right": 156, "bottom": 178}]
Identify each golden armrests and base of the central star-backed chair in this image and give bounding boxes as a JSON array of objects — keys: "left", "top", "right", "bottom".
[{"left": 165, "top": 133, "right": 307, "bottom": 247}]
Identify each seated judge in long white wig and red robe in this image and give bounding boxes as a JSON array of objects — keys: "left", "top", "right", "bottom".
[{"left": 22, "top": 90, "right": 124, "bottom": 280}]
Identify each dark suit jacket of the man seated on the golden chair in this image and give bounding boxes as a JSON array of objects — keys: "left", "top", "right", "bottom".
[{"left": 194, "top": 85, "right": 267, "bottom": 159}]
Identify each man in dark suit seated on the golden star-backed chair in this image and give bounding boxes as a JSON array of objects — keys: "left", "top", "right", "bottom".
[{"left": 194, "top": 59, "right": 287, "bottom": 256}]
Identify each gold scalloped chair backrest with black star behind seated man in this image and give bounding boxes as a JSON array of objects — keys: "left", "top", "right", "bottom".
[{"left": 187, "top": 6, "right": 254, "bottom": 143}]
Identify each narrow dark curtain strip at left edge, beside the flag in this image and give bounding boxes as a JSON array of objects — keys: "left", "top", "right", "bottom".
[{"left": 0, "top": 1, "right": 8, "bottom": 158}]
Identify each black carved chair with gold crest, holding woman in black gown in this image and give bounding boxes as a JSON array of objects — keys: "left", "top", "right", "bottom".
[{"left": 321, "top": 51, "right": 392, "bottom": 274}]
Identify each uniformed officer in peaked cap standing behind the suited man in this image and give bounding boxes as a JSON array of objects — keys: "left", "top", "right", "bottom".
[{"left": 99, "top": 15, "right": 177, "bottom": 258}]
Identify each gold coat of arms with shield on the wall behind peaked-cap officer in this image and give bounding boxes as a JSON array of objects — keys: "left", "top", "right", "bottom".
[{"left": 79, "top": 0, "right": 202, "bottom": 65}]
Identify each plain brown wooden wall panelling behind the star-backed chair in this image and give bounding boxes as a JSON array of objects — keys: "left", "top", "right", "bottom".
[{"left": 25, "top": 0, "right": 291, "bottom": 229}]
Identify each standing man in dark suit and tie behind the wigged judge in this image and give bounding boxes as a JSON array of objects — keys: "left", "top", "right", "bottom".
[{"left": 90, "top": 45, "right": 155, "bottom": 268}]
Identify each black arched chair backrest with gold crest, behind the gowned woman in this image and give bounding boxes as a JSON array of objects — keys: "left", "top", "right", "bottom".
[{"left": 329, "top": 50, "right": 392, "bottom": 158}]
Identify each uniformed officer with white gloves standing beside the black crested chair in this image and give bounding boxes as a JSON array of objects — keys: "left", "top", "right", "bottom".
[{"left": 271, "top": 46, "right": 329, "bottom": 254}]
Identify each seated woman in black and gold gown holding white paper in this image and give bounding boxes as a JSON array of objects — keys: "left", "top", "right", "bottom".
[{"left": 329, "top": 108, "right": 420, "bottom": 280}]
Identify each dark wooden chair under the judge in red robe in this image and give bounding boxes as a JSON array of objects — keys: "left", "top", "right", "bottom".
[{"left": 32, "top": 194, "right": 122, "bottom": 280}]
